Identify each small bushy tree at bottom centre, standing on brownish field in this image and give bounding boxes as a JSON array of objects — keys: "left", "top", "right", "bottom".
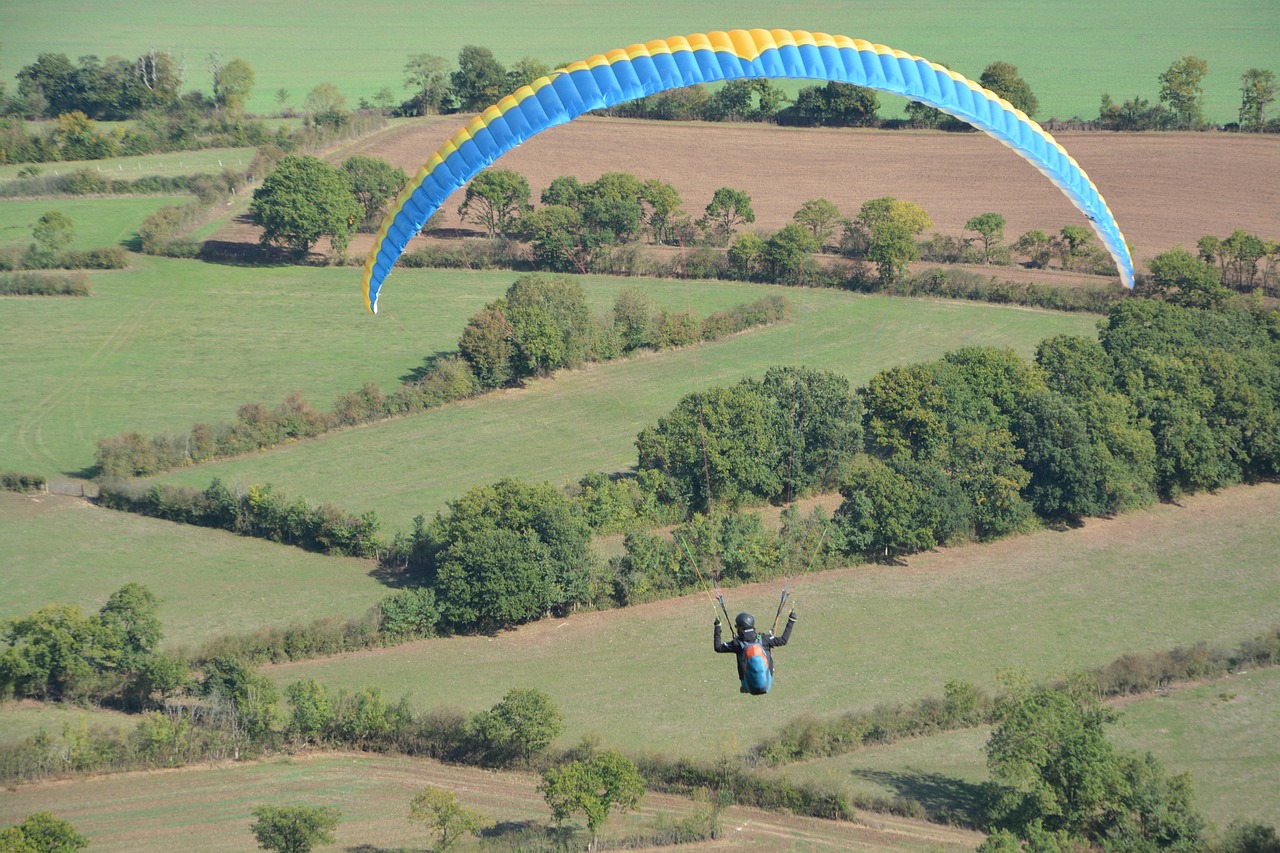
[{"left": 538, "top": 752, "right": 645, "bottom": 849}]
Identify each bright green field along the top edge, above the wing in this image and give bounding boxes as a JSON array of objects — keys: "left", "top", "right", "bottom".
[{"left": 3, "top": 0, "right": 1280, "bottom": 122}]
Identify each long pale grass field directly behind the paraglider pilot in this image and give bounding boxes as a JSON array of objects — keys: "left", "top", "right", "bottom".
[{"left": 268, "top": 484, "right": 1280, "bottom": 756}]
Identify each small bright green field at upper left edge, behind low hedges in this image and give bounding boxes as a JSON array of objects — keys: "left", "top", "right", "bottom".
[{"left": 0, "top": 196, "right": 187, "bottom": 252}]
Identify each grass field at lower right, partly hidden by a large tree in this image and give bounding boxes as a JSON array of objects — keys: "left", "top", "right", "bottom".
[{"left": 774, "top": 667, "right": 1280, "bottom": 827}]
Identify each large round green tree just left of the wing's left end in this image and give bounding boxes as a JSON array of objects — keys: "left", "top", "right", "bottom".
[{"left": 250, "top": 154, "right": 365, "bottom": 255}]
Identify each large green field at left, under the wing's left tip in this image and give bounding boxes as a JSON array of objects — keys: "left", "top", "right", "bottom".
[{"left": 0, "top": 256, "right": 763, "bottom": 476}]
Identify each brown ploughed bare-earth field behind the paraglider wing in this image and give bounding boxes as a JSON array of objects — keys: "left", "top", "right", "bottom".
[{"left": 304, "top": 117, "right": 1280, "bottom": 259}]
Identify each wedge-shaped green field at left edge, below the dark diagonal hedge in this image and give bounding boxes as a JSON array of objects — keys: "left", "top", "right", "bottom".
[{"left": 0, "top": 492, "right": 389, "bottom": 648}]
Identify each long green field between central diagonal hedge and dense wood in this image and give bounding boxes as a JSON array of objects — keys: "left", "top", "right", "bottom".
[{"left": 154, "top": 292, "right": 1098, "bottom": 530}]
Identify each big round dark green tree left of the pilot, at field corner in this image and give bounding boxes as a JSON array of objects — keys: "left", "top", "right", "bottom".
[{"left": 430, "top": 479, "right": 593, "bottom": 630}]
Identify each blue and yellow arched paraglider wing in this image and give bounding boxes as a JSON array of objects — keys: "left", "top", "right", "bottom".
[{"left": 364, "top": 29, "right": 1133, "bottom": 313}]
